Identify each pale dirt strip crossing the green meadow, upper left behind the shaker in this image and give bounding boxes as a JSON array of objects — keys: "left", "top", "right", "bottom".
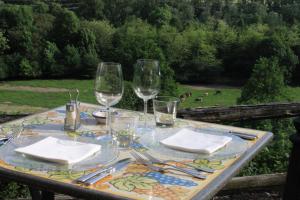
[{"left": 0, "top": 84, "right": 68, "bottom": 93}]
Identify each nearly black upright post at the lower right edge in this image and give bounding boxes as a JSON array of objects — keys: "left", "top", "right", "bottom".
[{"left": 283, "top": 117, "right": 300, "bottom": 200}]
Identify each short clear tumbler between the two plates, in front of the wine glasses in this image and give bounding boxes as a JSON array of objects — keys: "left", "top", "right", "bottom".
[{"left": 112, "top": 117, "right": 138, "bottom": 149}]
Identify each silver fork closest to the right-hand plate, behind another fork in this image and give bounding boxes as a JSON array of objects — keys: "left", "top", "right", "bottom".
[{"left": 140, "top": 151, "right": 215, "bottom": 173}]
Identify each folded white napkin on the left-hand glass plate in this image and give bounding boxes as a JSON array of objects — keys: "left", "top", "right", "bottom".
[{"left": 15, "top": 137, "right": 101, "bottom": 164}]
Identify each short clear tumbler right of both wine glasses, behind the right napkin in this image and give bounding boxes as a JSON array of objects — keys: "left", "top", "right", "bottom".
[{"left": 153, "top": 96, "right": 179, "bottom": 127}]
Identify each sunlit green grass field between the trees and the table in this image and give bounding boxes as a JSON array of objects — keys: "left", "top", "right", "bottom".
[{"left": 0, "top": 80, "right": 300, "bottom": 112}]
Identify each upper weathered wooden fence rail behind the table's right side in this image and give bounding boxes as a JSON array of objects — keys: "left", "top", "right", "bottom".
[{"left": 177, "top": 102, "right": 300, "bottom": 122}]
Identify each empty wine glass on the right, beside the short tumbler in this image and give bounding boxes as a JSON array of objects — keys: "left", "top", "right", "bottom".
[{"left": 132, "top": 59, "right": 160, "bottom": 128}]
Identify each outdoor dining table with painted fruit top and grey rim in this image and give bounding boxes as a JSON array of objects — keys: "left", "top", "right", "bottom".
[{"left": 0, "top": 103, "right": 273, "bottom": 200}]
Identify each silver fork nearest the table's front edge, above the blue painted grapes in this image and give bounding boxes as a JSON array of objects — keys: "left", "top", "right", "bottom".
[{"left": 130, "top": 151, "right": 206, "bottom": 179}]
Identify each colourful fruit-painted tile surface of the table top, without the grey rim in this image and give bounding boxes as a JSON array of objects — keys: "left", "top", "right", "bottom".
[{"left": 0, "top": 103, "right": 265, "bottom": 200}]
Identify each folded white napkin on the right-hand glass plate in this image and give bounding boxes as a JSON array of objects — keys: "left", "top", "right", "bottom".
[{"left": 160, "top": 128, "right": 231, "bottom": 154}]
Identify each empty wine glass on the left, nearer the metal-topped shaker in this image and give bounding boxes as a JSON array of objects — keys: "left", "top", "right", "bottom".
[{"left": 95, "top": 62, "right": 124, "bottom": 136}]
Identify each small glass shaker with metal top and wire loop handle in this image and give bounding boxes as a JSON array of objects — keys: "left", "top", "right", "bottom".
[{"left": 64, "top": 89, "right": 80, "bottom": 131}]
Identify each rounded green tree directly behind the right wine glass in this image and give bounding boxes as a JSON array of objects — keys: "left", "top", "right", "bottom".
[{"left": 113, "top": 19, "right": 177, "bottom": 95}]
